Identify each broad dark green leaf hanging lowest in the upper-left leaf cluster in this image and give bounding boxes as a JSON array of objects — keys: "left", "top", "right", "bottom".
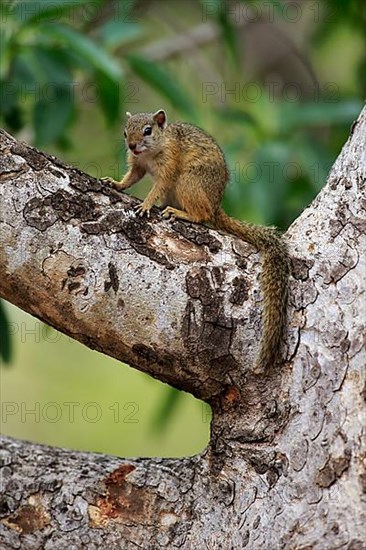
[{"left": 33, "top": 85, "right": 73, "bottom": 147}]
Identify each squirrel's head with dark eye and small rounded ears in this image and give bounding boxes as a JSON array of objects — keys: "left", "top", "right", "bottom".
[{"left": 124, "top": 109, "right": 167, "bottom": 155}]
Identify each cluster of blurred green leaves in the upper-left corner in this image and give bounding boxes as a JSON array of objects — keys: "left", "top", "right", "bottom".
[{"left": 0, "top": 0, "right": 122, "bottom": 147}]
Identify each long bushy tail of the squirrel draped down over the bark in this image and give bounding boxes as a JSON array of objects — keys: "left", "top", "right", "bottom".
[{"left": 215, "top": 210, "right": 290, "bottom": 369}]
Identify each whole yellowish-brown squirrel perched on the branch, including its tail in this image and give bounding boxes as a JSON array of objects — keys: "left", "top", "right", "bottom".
[{"left": 103, "top": 109, "right": 290, "bottom": 370}]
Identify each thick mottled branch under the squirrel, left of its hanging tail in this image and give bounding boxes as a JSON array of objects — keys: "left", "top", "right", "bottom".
[{"left": 0, "top": 132, "right": 284, "bottom": 420}]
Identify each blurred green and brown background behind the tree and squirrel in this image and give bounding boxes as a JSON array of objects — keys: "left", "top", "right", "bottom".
[{"left": 0, "top": 0, "right": 366, "bottom": 456}]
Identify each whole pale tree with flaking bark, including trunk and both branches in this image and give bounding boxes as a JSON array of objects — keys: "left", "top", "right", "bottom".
[{"left": 0, "top": 110, "right": 366, "bottom": 550}]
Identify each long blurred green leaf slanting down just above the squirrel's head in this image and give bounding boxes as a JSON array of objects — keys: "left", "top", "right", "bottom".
[{"left": 126, "top": 55, "right": 195, "bottom": 120}]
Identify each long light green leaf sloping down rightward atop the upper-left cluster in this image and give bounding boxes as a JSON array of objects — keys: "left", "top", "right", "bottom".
[{"left": 39, "top": 23, "right": 122, "bottom": 82}]
